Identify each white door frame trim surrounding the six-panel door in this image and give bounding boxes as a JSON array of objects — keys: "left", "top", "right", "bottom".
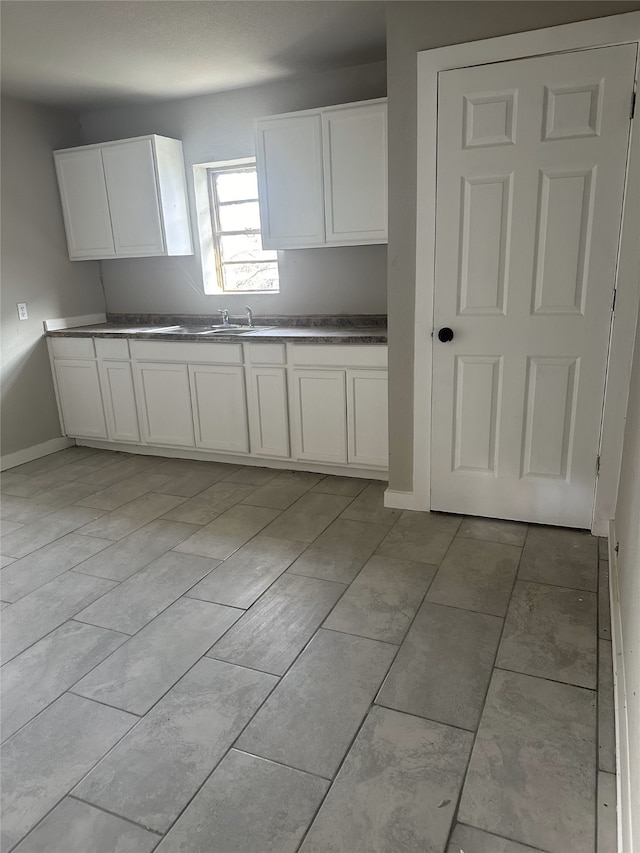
[{"left": 408, "top": 12, "right": 640, "bottom": 536}]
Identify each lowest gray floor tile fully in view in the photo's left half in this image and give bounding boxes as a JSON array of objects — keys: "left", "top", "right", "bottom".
[{"left": 73, "top": 658, "right": 277, "bottom": 832}]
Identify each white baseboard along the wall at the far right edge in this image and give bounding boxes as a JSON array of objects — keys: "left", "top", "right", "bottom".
[{"left": 609, "top": 519, "right": 636, "bottom": 853}]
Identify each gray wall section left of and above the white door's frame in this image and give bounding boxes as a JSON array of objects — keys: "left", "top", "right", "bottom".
[{"left": 387, "top": 0, "right": 640, "bottom": 491}]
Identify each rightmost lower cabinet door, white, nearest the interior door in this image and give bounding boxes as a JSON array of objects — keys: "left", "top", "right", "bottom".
[{"left": 347, "top": 370, "right": 389, "bottom": 468}]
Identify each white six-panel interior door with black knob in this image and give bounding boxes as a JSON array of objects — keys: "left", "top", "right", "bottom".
[{"left": 431, "top": 45, "right": 636, "bottom": 527}]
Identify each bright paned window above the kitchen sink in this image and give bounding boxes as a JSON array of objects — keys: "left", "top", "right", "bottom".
[{"left": 205, "top": 164, "right": 279, "bottom": 293}]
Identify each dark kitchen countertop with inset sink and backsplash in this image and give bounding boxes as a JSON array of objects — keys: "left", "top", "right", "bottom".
[{"left": 47, "top": 315, "right": 387, "bottom": 344}]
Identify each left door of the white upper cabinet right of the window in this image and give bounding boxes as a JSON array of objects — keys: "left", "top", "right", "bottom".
[{"left": 256, "top": 114, "right": 325, "bottom": 249}]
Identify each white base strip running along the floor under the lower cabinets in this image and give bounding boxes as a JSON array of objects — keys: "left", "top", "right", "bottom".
[{"left": 76, "top": 438, "right": 387, "bottom": 480}]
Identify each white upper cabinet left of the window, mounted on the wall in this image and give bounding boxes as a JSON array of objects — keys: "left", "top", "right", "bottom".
[{"left": 54, "top": 135, "right": 193, "bottom": 260}]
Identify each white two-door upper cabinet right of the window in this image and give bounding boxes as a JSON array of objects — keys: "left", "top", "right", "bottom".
[{"left": 256, "top": 98, "right": 387, "bottom": 249}]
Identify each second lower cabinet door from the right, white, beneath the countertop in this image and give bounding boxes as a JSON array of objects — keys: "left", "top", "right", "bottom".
[{"left": 291, "top": 370, "right": 347, "bottom": 463}]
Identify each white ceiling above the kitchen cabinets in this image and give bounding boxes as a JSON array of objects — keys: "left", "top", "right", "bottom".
[{"left": 0, "top": 0, "right": 386, "bottom": 109}]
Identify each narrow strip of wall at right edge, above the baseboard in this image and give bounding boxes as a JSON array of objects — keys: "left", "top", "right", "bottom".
[{"left": 615, "top": 300, "right": 640, "bottom": 850}]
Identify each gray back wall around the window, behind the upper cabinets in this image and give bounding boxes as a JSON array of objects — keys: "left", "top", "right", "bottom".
[{"left": 81, "top": 62, "right": 387, "bottom": 314}]
